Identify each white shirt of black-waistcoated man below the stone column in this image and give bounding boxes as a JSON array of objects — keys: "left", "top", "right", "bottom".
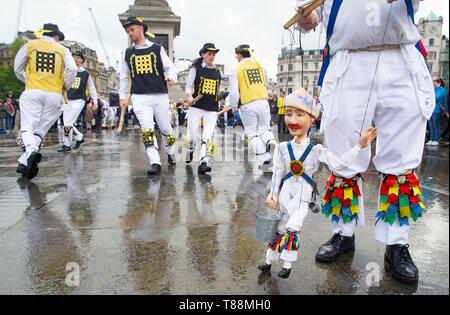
[{"left": 119, "top": 39, "right": 178, "bottom": 100}]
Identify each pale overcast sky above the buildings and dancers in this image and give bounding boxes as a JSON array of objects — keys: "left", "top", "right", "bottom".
[{"left": 0, "top": 0, "right": 449, "bottom": 78}]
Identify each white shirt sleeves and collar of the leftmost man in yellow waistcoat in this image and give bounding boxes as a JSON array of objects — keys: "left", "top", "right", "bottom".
[{"left": 14, "top": 35, "right": 78, "bottom": 90}]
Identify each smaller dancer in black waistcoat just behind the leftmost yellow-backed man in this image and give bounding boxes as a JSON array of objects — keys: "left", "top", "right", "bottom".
[{"left": 58, "top": 51, "right": 97, "bottom": 152}]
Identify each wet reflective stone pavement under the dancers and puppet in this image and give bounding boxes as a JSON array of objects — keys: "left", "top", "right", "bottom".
[{"left": 0, "top": 128, "right": 449, "bottom": 295}]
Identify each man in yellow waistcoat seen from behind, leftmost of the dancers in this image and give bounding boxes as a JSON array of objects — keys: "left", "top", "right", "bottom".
[{"left": 14, "top": 23, "right": 77, "bottom": 179}]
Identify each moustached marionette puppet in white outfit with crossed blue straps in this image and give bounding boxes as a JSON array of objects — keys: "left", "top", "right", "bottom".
[{"left": 258, "top": 89, "right": 377, "bottom": 278}]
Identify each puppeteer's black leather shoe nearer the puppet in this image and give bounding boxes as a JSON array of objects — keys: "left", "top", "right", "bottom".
[{"left": 316, "top": 233, "right": 355, "bottom": 262}]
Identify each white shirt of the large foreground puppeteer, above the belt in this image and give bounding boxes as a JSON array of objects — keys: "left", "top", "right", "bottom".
[{"left": 315, "top": 0, "right": 420, "bottom": 54}]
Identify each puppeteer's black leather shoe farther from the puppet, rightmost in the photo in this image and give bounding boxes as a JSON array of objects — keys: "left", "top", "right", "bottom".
[{"left": 384, "top": 244, "right": 419, "bottom": 283}]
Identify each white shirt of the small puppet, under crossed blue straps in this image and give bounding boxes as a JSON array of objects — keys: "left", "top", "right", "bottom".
[{"left": 271, "top": 138, "right": 362, "bottom": 212}]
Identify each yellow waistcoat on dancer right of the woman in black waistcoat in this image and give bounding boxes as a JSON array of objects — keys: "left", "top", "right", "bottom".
[{"left": 236, "top": 59, "right": 269, "bottom": 105}]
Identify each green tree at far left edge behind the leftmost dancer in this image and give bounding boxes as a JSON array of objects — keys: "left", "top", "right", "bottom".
[{"left": 0, "top": 37, "right": 26, "bottom": 98}]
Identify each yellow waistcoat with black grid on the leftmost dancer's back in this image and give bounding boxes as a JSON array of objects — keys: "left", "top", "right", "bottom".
[{"left": 25, "top": 39, "right": 66, "bottom": 93}]
